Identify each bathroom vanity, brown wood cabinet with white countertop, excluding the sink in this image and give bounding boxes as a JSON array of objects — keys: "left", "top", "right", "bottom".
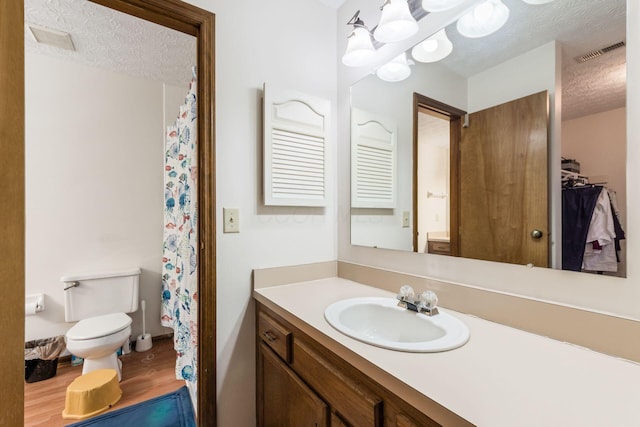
[{"left": 254, "top": 277, "right": 640, "bottom": 427}]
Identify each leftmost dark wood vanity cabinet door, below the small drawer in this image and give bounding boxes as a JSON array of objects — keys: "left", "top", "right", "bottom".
[{"left": 258, "top": 343, "right": 329, "bottom": 427}]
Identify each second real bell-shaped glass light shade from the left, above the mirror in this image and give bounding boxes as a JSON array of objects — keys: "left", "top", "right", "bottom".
[{"left": 373, "top": 0, "right": 418, "bottom": 43}]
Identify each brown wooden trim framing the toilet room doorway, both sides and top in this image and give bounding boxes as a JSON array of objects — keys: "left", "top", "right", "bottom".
[{"left": 8, "top": 0, "right": 217, "bottom": 426}]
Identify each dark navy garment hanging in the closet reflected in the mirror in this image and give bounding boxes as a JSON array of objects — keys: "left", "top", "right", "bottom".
[{"left": 562, "top": 186, "right": 602, "bottom": 271}]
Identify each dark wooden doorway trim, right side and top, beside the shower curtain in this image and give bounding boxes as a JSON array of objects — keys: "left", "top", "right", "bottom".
[{"left": 91, "top": 0, "right": 217, "bottom": 426}]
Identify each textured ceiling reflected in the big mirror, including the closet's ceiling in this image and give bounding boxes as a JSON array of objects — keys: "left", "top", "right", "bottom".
[{"left": 436, "top": 0, "right": 626, "bottom": 120}]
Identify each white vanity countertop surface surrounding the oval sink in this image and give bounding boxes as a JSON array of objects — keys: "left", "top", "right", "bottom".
[{"left": 254, "top": 278, "right": 640, "bottom": 427}]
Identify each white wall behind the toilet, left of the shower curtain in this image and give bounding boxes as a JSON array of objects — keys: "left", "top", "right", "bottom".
[{"left": 25, "top": 54, "right": 186, "bottom": 340}]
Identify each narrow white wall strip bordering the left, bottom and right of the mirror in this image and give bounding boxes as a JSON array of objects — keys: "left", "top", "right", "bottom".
[{"left": 338, "top": 0, "right": 640, "bottom": 319}]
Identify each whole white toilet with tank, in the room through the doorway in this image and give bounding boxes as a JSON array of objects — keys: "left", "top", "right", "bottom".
[{"left": 60, "top": 268, "right": 140, "bottom": 381}]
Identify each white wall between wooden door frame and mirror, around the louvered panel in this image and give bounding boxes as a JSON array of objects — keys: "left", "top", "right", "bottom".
[{"left": 180, "top": 0, "right": 338, "bottom": 427}]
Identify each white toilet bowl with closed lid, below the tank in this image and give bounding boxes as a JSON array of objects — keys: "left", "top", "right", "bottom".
[{"left": 65, "top": 313, "right": 132, "bottom": 381}]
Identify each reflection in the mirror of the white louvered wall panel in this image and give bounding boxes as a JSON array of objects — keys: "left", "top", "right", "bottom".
[{"left": 351, "top": 108, "right": 397, "bottom": 208}]
